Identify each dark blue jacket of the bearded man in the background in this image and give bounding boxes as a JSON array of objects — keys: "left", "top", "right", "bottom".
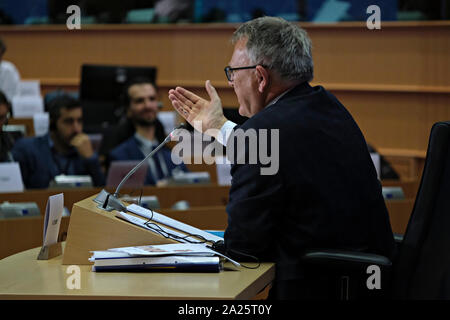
[{"left": 109, "top": 136, "right": 188, "bottom": 185}]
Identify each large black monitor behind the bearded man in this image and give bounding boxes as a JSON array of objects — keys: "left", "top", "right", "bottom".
[{"left": 80, "top": 64, "right": 157, "bottom": 133}]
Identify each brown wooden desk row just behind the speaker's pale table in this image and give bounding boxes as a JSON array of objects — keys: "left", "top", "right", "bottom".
[{"left": 0, "top": 181, "right": 418, "bottom": 259}]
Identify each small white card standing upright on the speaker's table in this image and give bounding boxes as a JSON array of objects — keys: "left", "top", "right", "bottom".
[{"left": 44, "top": 193, "right": 64, "bottom": 246}]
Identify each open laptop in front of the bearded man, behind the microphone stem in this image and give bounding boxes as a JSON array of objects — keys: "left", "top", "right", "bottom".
[{"left": 106, "top": 160, "right": 148, "bottom": 188}]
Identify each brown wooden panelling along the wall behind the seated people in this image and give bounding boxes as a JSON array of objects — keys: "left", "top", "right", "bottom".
[{"left": 0, "top": 21, "right": 450, "bottom": 178}]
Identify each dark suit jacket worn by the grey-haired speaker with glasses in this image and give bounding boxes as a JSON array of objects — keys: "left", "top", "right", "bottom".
[{"left": 225, "top": 83, "right": 394, "bottom": 299}]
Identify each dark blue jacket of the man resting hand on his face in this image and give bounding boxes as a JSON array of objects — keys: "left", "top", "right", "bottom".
[{"left": 11, "top": 134, "right": 105, "bottom": 188}]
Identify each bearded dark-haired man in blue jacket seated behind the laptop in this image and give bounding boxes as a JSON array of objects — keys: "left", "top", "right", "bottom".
[{"left": 109, "top": 79, "right": 187, "bottom": 185}]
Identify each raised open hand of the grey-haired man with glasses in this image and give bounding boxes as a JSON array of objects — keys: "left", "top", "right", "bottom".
[{"left": 169, "top": 80, "right": 227, "bottom": 132}]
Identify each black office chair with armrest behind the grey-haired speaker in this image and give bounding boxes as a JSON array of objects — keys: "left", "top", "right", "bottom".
[{"left": 303, "top": 122, "right": 450, "bottom": 300}]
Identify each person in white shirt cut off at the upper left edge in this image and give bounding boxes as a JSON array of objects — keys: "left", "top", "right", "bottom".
[{"left": 0, "top": 38, "right": 20, "bottom": 101}]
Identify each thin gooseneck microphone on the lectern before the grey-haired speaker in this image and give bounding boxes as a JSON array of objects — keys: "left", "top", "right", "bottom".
[{"left": 94, "top": 123, "right": 186, "bottom": 211}]
